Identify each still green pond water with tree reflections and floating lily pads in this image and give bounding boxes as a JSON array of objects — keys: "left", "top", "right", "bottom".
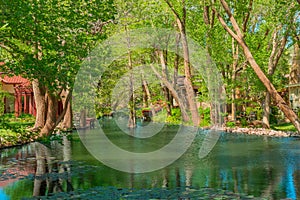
[{"left": 0, "top": 121, "right": 300, "bottom": 200}]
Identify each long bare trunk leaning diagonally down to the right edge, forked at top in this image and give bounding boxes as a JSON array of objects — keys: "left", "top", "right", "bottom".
[{"left": 218, "top": 0, "right": 300, "bottom": 132}]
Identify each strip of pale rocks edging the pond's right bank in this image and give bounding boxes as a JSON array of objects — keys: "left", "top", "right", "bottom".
[{"left": 224, "top": 127, "right": 300, "bottom": 137}]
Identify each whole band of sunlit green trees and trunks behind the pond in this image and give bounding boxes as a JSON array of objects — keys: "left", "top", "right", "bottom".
[{"left": 0, "top": 0, "right": 300, "bottom": 136}]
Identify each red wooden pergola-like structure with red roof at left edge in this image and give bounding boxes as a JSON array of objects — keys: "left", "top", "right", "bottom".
[{"left": 0, "top": 75, "right": 36, "bottom": 117}]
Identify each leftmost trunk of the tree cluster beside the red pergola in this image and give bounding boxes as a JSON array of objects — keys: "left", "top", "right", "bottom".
[{"left": 32, "top": 79, "right": 46, "bottom": 130}]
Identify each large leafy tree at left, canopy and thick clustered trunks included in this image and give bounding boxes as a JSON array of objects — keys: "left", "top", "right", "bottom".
[{"left": 0, "top": 0, "right": 113, "bottom": 135}]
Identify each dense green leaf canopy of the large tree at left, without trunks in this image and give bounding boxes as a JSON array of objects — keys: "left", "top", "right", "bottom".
[{"left": 0, "top": 0, "right": 114, "bottom": 91}]
